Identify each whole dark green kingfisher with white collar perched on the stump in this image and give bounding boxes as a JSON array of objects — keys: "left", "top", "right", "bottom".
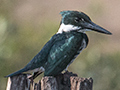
[{"left": 6, "top": 10, "right": 112, "bottom": 79}]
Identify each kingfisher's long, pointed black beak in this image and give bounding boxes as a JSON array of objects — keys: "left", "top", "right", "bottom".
[{"left": 85, "top": 21, "right": 112, "bottom": 35}]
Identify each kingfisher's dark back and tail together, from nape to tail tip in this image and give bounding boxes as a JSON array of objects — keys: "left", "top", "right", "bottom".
[{"left": 5, "top": 34, "right": 60, "bottom": 77}]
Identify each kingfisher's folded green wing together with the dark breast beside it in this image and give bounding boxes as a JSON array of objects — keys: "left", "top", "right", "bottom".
[{"left": 45, "top": 32, "right": 87, "bottom": 75}]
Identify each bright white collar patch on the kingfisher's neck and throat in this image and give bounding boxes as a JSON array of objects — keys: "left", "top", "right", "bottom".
[{"left": 57, "top": 23, "right": 81, "bottom": 33}]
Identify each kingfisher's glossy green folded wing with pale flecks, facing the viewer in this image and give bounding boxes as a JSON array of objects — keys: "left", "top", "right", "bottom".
[{"left": 44, "top": 32, "right": 82, "bottom": 76}]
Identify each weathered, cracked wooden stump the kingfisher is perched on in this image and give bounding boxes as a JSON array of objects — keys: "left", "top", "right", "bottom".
[{"left": 6, "top": 72, "right": 93, "bottom": 90}]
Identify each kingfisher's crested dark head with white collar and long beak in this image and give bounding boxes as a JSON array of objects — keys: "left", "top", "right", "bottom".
[{"left": 57, "top": 11, "right": 112, "bottom": 35}]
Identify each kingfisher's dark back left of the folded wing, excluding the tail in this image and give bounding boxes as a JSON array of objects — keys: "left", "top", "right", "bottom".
[{"left": 25, "top": 34, "right": 63, "bottom": 70}]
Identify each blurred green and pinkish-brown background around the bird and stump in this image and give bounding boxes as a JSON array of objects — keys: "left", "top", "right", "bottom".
[{"left": 0, "top": 0, "right": 120, "bottom": 90}]
